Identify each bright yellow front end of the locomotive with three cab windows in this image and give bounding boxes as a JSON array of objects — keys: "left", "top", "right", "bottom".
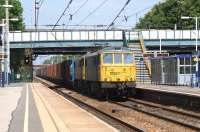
[{"left": 99, "top": 49, "right": 136, "bottom": 96}]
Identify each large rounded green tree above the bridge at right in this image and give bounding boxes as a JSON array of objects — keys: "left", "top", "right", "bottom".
[{"left": 136, "top": 0, "right": 200, "bottom": 29}]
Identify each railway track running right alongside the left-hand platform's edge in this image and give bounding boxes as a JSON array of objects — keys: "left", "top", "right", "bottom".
[{"left": 34, "top": 79, "right": 144, "bottom": 132}]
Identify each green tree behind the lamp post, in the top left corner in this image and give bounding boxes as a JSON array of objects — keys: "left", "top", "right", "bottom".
[{"left": 0, "top": 0, "right": 25, "bottom": 30}]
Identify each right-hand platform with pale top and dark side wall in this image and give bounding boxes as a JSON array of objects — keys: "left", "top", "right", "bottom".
[{"left": 136, "top": 84, "right": 200, "bottom": 112}]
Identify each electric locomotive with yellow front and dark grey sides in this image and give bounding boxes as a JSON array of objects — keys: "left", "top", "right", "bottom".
[{"left": 74, "top": 47, "right": 136, "bottom": 97}]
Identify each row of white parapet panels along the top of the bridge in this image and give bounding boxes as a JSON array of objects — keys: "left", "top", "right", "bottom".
[{"left": 9, "top": 29, "right": 200, "bottom": 42}]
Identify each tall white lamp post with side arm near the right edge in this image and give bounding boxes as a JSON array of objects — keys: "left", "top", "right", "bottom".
[{"left": 181, "top": 16, "right": 200, "bottom": 86}]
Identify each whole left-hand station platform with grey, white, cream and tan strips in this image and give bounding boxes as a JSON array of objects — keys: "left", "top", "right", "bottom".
[{"left": 0, "top": 83, "right": 118, "bottom": 132}]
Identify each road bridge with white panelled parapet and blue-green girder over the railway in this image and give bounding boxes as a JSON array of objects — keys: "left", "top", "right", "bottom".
[{"left": 9, "top": 29, "right": 200, "bottom": 54}]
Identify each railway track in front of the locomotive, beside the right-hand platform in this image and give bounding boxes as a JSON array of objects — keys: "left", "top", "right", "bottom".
[{"left": 110, "top": 99, "right": 200, "bottom": 131}]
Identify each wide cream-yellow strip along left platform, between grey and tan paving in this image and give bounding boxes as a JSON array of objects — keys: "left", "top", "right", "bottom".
[{"left": 31, "top": 84, "right": 70, "bottom": 132}]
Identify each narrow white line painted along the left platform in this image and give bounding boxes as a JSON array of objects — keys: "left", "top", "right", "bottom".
[{"left": 24, "top": 84, "right": 29, "bottom": 132}]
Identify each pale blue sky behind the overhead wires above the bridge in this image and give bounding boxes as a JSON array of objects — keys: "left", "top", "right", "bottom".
[{"left": 20, "top": 0, "right": 161, "bottom": 27}]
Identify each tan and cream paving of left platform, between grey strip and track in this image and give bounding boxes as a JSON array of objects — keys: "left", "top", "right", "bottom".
[{"left": 32, "top": 83, "right": 117, "bottom": 132}]
